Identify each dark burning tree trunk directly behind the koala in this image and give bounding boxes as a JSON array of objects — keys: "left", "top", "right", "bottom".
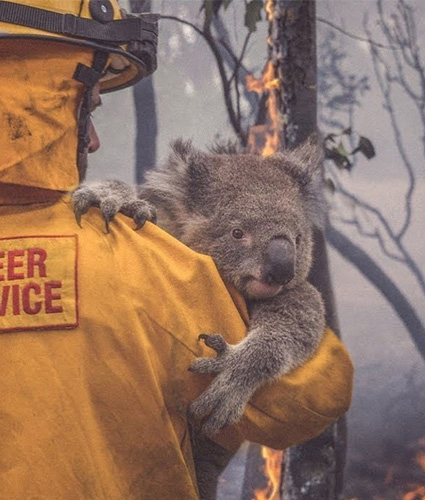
[{"left": 268, "top": 0, "right": 345, "bottom": 500}]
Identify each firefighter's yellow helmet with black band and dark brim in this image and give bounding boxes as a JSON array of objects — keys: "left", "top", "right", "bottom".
[{"left": 0, "top": 0, "right": 159, "bottom": 92}]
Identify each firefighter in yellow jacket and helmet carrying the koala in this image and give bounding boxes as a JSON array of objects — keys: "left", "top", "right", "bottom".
[{"left": 0, "top": 0, "right": 352, "bottom": 500}]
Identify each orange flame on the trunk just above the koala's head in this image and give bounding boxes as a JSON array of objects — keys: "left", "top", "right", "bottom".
[{"left": 246, "top": 61, "right": 282, "bottom": 156}]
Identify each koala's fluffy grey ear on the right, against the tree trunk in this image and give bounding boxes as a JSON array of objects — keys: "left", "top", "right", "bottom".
[{"left": 281, "top": 136, "right": 327, "bottom": 228}]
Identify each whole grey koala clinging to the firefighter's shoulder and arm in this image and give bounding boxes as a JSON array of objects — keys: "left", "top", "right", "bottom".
[{"left": 74, "top": 136, "right": 325, "bottom": 436}]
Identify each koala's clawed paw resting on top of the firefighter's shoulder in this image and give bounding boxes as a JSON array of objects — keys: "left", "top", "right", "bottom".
[{"left": 72, "top": 181, "right": 156, "bottom": 232}]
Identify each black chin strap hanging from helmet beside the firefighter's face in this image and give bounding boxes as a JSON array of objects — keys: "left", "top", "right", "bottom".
[{"left": 74, "top": 51, "right": 109, "bottom": 153}]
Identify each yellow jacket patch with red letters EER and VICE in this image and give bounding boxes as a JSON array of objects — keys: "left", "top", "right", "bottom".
[{"left": 0, "top": 235, "right": 78, "bottom": 333}]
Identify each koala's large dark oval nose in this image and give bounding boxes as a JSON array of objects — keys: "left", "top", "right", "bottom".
[{"left": 264, "top": 238, "right": 295, "bottom": 285}]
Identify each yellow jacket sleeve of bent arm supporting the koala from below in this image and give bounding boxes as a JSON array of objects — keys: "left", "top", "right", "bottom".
[{"left": 217, "top": 329, "right": 353, "bottom": 450}]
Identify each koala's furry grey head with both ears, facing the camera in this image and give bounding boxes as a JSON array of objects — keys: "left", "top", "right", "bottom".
[{"left": 142, "top": 141, "right": 325, "bottom": 299}]
